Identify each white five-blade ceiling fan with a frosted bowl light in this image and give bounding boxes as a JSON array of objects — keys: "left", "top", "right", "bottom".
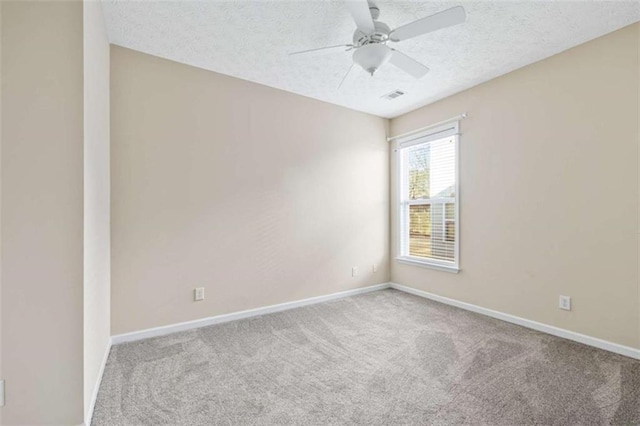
[{"left": 289, "top": 0, "right": 466, "bottom": 88}]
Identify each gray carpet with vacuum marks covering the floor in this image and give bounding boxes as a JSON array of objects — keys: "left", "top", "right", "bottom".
[{"left": 93, "top": 290, "right": 640, "bottom": 425}]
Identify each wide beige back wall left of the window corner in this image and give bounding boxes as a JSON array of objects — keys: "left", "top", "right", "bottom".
[{"left": 111, "top": 47, "right": 389, "bottom": 334}]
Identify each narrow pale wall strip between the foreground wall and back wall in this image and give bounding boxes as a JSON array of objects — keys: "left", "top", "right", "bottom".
[{"left": 83, "top": 0, "right": 111, "bottom": 418}]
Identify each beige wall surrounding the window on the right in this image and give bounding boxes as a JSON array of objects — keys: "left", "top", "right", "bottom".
[{"left": 391, "top": 24, "right": 640, "bottom": 348}]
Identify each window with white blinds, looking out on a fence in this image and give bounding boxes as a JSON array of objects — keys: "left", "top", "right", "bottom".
[{"left": 398, "top": 122, "right": 459, "bottom": 272}]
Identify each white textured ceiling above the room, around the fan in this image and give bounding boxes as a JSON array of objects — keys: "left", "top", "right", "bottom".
[{"left": 103, "top": 0, "right": 640, "bottom": 118}]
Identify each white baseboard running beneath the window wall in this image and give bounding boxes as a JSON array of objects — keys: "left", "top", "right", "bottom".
[{"left": 391, "top": 283, "right": 640, "bottom": 359}]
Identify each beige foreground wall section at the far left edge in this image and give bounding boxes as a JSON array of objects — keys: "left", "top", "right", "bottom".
[{"left": 1, "top": 1, "right": 83, "bottom": 425}]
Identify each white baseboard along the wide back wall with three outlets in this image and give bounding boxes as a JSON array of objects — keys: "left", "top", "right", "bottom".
[{"left": 111, "top": 283, "right": 391, "bottom": 345}]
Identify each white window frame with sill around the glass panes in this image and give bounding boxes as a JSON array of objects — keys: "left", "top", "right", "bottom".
[{"left": 395, "top": 121, "right": 460, "bottom": 273}]
